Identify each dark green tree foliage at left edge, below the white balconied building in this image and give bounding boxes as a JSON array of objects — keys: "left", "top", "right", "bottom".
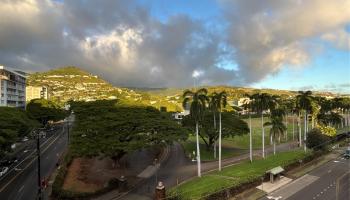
[{"left": 0, "top": 107, "right": 39, "bottom": 155}]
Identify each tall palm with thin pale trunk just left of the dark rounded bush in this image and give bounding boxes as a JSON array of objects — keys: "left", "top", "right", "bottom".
[{"left": 297, "top": 91, "right": 312, "bottom": 152}]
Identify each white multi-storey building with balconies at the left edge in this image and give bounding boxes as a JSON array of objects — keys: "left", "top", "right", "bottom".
[{"left": 0, "top": 65, "right": 26, "bottom": 108}]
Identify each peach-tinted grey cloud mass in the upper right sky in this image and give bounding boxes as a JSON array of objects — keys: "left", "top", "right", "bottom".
[{"left": 221, "top": 0, "right": 350, "bottom": 83}]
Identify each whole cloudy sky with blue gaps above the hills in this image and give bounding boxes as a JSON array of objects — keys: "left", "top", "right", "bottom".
[{"left": 0, "top": 0, "right": 350, "bottom": 93}]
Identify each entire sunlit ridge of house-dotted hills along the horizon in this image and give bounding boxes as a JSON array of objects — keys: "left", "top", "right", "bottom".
[{"left": 27, "top": 66, "right": 340, "bottom": 111}]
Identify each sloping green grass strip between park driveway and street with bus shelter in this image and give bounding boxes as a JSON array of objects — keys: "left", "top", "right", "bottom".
[{"left": 168, "top": 150, "right": 309, "bottom": 199}]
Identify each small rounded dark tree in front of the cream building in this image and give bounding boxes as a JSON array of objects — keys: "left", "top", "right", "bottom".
[{"left": 26, "top": 99, "right": 67, "bottom": 125}]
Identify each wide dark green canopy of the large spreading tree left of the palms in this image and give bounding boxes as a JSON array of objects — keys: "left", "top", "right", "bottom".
[{"left": 71, "top": 100, "right": 188, "bottom": 162}]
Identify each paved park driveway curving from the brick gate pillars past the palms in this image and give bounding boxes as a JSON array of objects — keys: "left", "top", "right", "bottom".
[{"left": 119, "top": 143, "right": 291, "bottom": 200}]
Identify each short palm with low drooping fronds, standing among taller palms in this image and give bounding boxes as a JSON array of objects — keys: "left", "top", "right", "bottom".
[{"left": 264, "top": 109, "right": 287, "bottom": 155}]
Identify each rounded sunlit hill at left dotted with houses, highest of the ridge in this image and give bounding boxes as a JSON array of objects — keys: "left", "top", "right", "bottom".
[{"left": 27, "top": 67, "right": 136, "bottom": 102}]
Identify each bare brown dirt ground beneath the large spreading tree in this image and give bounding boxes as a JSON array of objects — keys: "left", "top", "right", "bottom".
[{"left": 63, "top": 149, "right": 159, "bottom": 193}]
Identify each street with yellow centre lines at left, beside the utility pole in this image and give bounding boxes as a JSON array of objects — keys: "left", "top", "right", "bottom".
[{"left": 0, "top": 122, "right": 67, "bottom": 200}]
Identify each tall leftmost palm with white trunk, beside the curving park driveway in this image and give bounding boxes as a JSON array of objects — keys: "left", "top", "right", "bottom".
[{"left": 182, "top": 88, "right": 208, "bottom": 177}]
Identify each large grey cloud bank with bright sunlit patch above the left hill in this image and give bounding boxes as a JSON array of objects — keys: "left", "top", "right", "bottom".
[{"left": 0, "top": 0, "right": 235, "bottom": 87}]
